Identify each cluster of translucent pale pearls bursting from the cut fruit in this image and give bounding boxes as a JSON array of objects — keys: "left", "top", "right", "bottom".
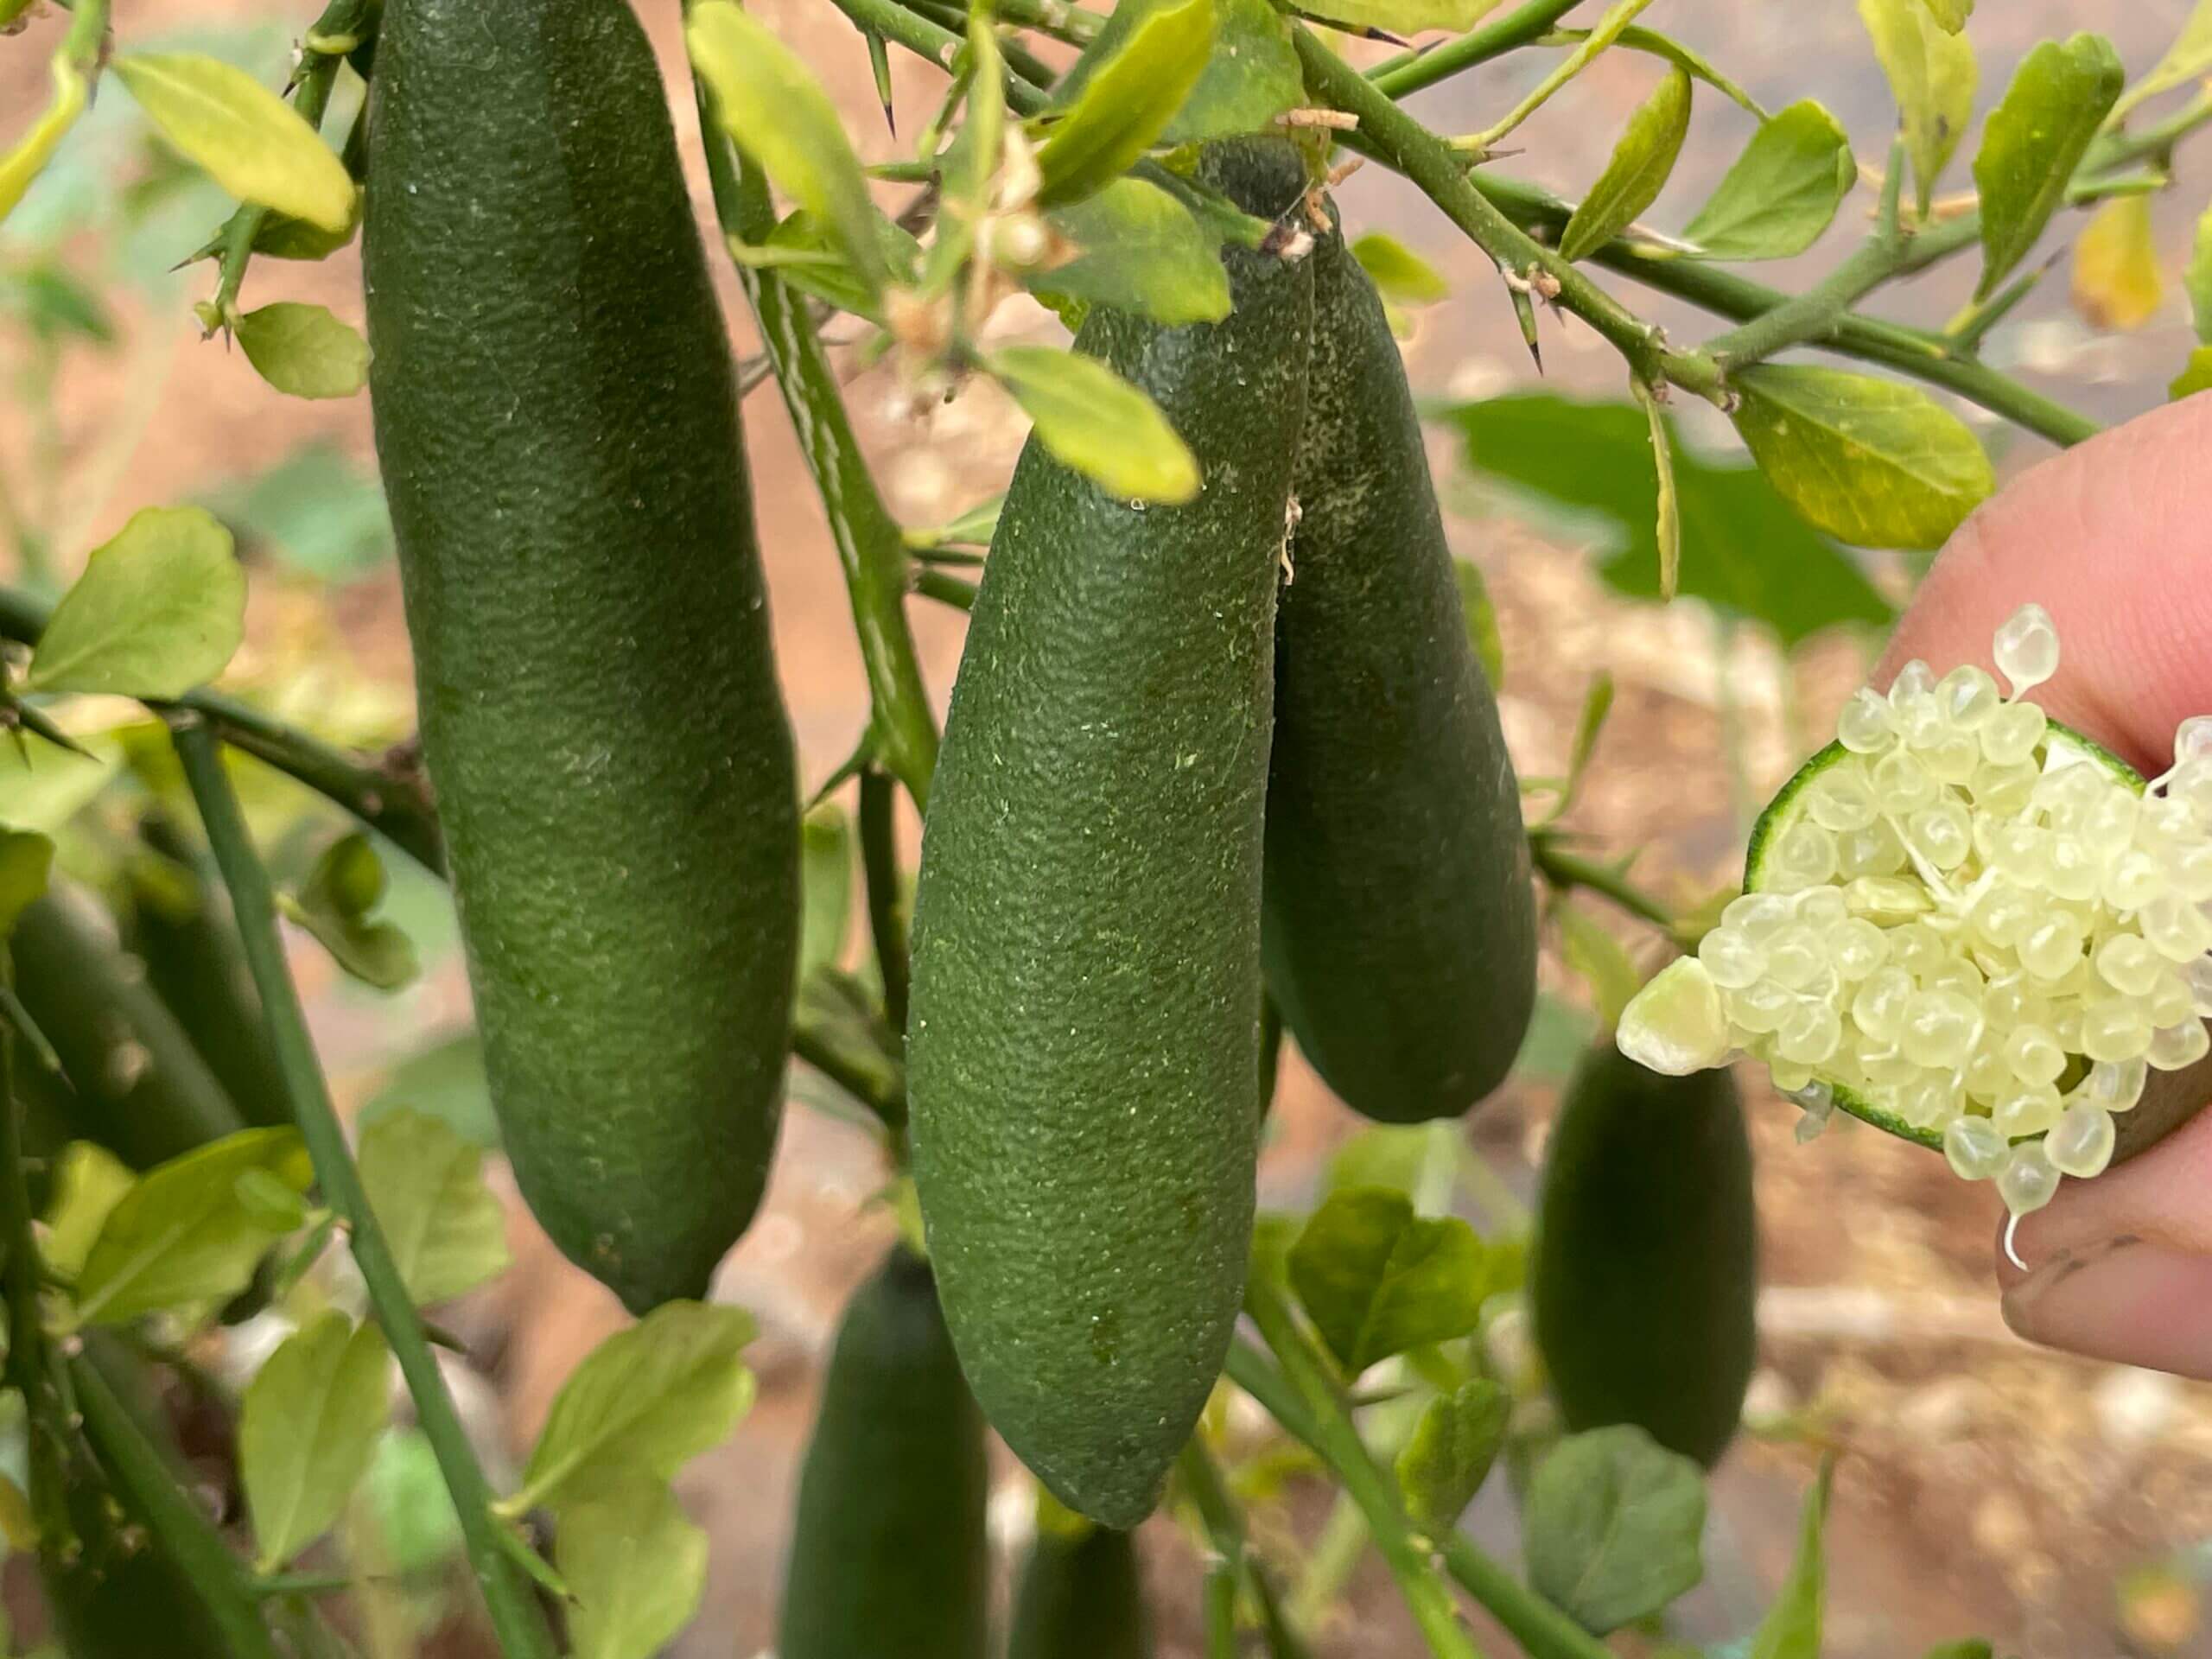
[{"left": 1624, "top": 604, "right": 2212, "bottom": 1217}]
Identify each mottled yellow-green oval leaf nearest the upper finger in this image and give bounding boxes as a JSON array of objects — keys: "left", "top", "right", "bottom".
[{"left": 1732, "top": 365, "right": 1998, "bottom": 550}]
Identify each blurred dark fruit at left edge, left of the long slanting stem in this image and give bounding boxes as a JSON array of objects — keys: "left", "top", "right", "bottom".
[{"left": 9, "top": 887, "right": 245, "bottom": 1170}]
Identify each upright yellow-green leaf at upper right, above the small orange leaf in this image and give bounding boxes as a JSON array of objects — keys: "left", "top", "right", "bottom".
[{"left": 1974, "top": 33, "right": 2126, "bottom": 301}]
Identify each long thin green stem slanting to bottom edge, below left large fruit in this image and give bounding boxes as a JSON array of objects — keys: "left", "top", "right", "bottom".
[{"left": 168, "top": 712, "right": 556, "bottom": 1659}]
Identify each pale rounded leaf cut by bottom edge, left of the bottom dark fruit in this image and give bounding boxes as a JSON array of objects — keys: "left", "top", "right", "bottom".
[{"left": 556, "top": 1471, "right": 706, "bottom": 1659}]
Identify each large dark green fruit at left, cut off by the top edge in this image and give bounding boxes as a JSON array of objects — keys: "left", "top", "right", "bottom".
[{"left": 363, "top": 0, "right": 798, "bottom": 1312}]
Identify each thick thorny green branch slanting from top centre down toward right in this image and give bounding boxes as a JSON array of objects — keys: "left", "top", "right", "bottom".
[{"left": 1292, "top": 22, "right": 1663, "bottom": 383}]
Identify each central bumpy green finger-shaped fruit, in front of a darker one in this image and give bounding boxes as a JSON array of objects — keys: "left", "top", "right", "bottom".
[{"left": 907, "top": 142, "right": 1312, "bottom": 1526}]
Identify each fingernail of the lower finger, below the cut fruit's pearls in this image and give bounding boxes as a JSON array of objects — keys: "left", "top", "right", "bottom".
[{"left": 2004, "top": 1234, "right": 2212, "bottom": 1376}]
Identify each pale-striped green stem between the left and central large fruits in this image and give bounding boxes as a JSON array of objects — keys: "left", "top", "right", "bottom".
[{"left": 695, "top": 67, "right": 938, "bottom": 807}]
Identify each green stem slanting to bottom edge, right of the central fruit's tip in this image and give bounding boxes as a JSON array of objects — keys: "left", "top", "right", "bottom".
[{"left": 1228, "top": 1309, "right": 1482, "bottom": 1659}]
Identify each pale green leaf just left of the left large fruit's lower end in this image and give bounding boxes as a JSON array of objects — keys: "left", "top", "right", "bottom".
[{"left": 356, "top": 1109, "right": 509, "bottom": 1307}]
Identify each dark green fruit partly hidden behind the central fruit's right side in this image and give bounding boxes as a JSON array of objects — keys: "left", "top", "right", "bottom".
[{"left": 1263, "top": 214, "right": 1535, "bottom": 1123}]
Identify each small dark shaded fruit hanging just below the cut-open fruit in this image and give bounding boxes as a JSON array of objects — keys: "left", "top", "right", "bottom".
[{"left": 1531, "top": 1039, "right": 1758, "bottom": 1466}]
